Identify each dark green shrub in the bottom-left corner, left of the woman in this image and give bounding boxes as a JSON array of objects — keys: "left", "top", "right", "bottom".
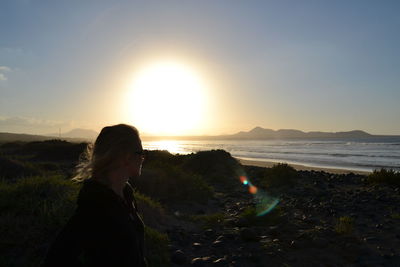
[{"left": 0, "top": 176, "right": 78, "bottom": 266}]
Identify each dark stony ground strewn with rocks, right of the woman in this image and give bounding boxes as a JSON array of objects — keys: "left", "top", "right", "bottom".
[{"left": 166, "top": 170, "right": 400, "bottom": 266}]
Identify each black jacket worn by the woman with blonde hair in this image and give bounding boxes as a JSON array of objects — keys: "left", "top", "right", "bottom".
[{"left": 43, "top": 179, "right": 146, "bottom": 267}]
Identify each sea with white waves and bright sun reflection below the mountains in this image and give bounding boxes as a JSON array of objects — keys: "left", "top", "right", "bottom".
[{"left": 143, "top": 137, "right": 400, "bottom": 172}]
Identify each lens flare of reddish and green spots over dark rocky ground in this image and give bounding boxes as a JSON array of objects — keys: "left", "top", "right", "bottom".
[{"left": 239, "top": 175, "right": 279, "bottom": 216}]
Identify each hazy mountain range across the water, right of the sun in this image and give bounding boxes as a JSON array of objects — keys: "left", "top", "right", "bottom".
[{"left": 221, "top": 127, "right": 373, "bottom": 139}]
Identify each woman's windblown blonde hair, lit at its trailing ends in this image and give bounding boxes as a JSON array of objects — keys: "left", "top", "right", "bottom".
[{"left": 72, "top": 124, "right": 141, "bottom": 182}]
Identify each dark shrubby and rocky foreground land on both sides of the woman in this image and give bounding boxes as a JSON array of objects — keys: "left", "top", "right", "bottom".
[{"left": 0, "top": 140, "right": 400, "bottom": 266}]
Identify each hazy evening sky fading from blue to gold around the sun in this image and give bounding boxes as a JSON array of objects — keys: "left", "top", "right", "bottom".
[{"left": 0, "top": 0, "right": 400, "bottom": 135}]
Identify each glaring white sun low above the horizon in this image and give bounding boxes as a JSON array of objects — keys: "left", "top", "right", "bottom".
[{"left": 128, "top": 61, "right": 206, "bottom": 135}]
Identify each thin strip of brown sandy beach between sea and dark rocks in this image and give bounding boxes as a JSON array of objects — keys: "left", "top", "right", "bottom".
[{"left": 236, "top": 158, "right": 372, "bottom": 175}]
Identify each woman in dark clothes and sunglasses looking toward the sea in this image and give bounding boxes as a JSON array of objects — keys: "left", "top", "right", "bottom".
[{"left": 44, "top": 124, "right": 146, "bottom": 267}]
